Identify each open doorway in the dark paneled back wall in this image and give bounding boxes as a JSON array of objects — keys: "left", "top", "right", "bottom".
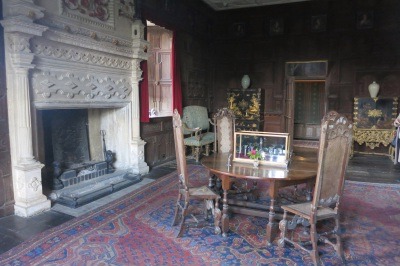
[{"left": 294, "top": 80, "right": 325, "bottom": 140}]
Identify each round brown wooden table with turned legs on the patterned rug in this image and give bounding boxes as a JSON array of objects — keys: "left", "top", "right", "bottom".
[{"left": 201, "top": 153, "right": 317, "bottom": 244}]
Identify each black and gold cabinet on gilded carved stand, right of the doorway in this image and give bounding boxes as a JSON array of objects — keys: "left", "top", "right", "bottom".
[{"left": 351, "top": 97, "right": 398, "bottom": 155}]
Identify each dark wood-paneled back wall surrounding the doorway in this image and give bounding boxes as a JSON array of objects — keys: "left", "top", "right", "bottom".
[{"left": 212, "top": 0, "right": 400, "bottom": 130}]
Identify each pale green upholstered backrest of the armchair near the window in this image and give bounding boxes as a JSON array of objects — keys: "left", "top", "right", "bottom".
[{"left": 182, "top": 105, "right": 210, "bottom": 135}]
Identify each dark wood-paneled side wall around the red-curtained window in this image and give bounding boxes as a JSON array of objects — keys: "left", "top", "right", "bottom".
[{"left": 141, "top": 0, "right": 214, "bottom": 167}]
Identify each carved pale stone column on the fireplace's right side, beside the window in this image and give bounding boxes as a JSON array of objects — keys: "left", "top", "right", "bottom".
[{"left": 130, "top": 20, "right": 149, "bottom": 174}]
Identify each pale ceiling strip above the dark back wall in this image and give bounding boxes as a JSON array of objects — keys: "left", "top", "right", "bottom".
[{"left": 202, "top": 0, "right": 310, "bottom": 11}]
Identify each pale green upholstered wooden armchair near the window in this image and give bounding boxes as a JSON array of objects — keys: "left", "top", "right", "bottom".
[{"left": 182, "top": 105, "right": 215, "bottom": 162}]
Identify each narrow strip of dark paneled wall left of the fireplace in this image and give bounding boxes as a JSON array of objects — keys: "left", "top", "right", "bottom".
[{"left": 0, "top": 1, "right": 14, "bottom": 217}]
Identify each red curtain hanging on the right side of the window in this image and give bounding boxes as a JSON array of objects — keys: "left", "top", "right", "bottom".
[{"left": 171, "top": 31, "right": 182, "bottom": 114}]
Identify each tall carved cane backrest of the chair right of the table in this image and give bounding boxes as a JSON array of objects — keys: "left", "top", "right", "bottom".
[{"left": 312, "top": 111, "right": 353, "bottom": 211}]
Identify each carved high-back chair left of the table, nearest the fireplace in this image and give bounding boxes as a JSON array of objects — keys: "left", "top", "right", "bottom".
[{"left": 172, "top": 109, "right": 221, "bottom": 237}]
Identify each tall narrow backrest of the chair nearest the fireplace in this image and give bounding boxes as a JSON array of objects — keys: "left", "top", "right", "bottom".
[{"left": 172, "top": 109, "right": 188, "bottom": 188}]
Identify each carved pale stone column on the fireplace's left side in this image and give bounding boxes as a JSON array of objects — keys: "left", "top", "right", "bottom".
[{"left": 1, "top": 0, "right": 50, "bottom": 217}]
